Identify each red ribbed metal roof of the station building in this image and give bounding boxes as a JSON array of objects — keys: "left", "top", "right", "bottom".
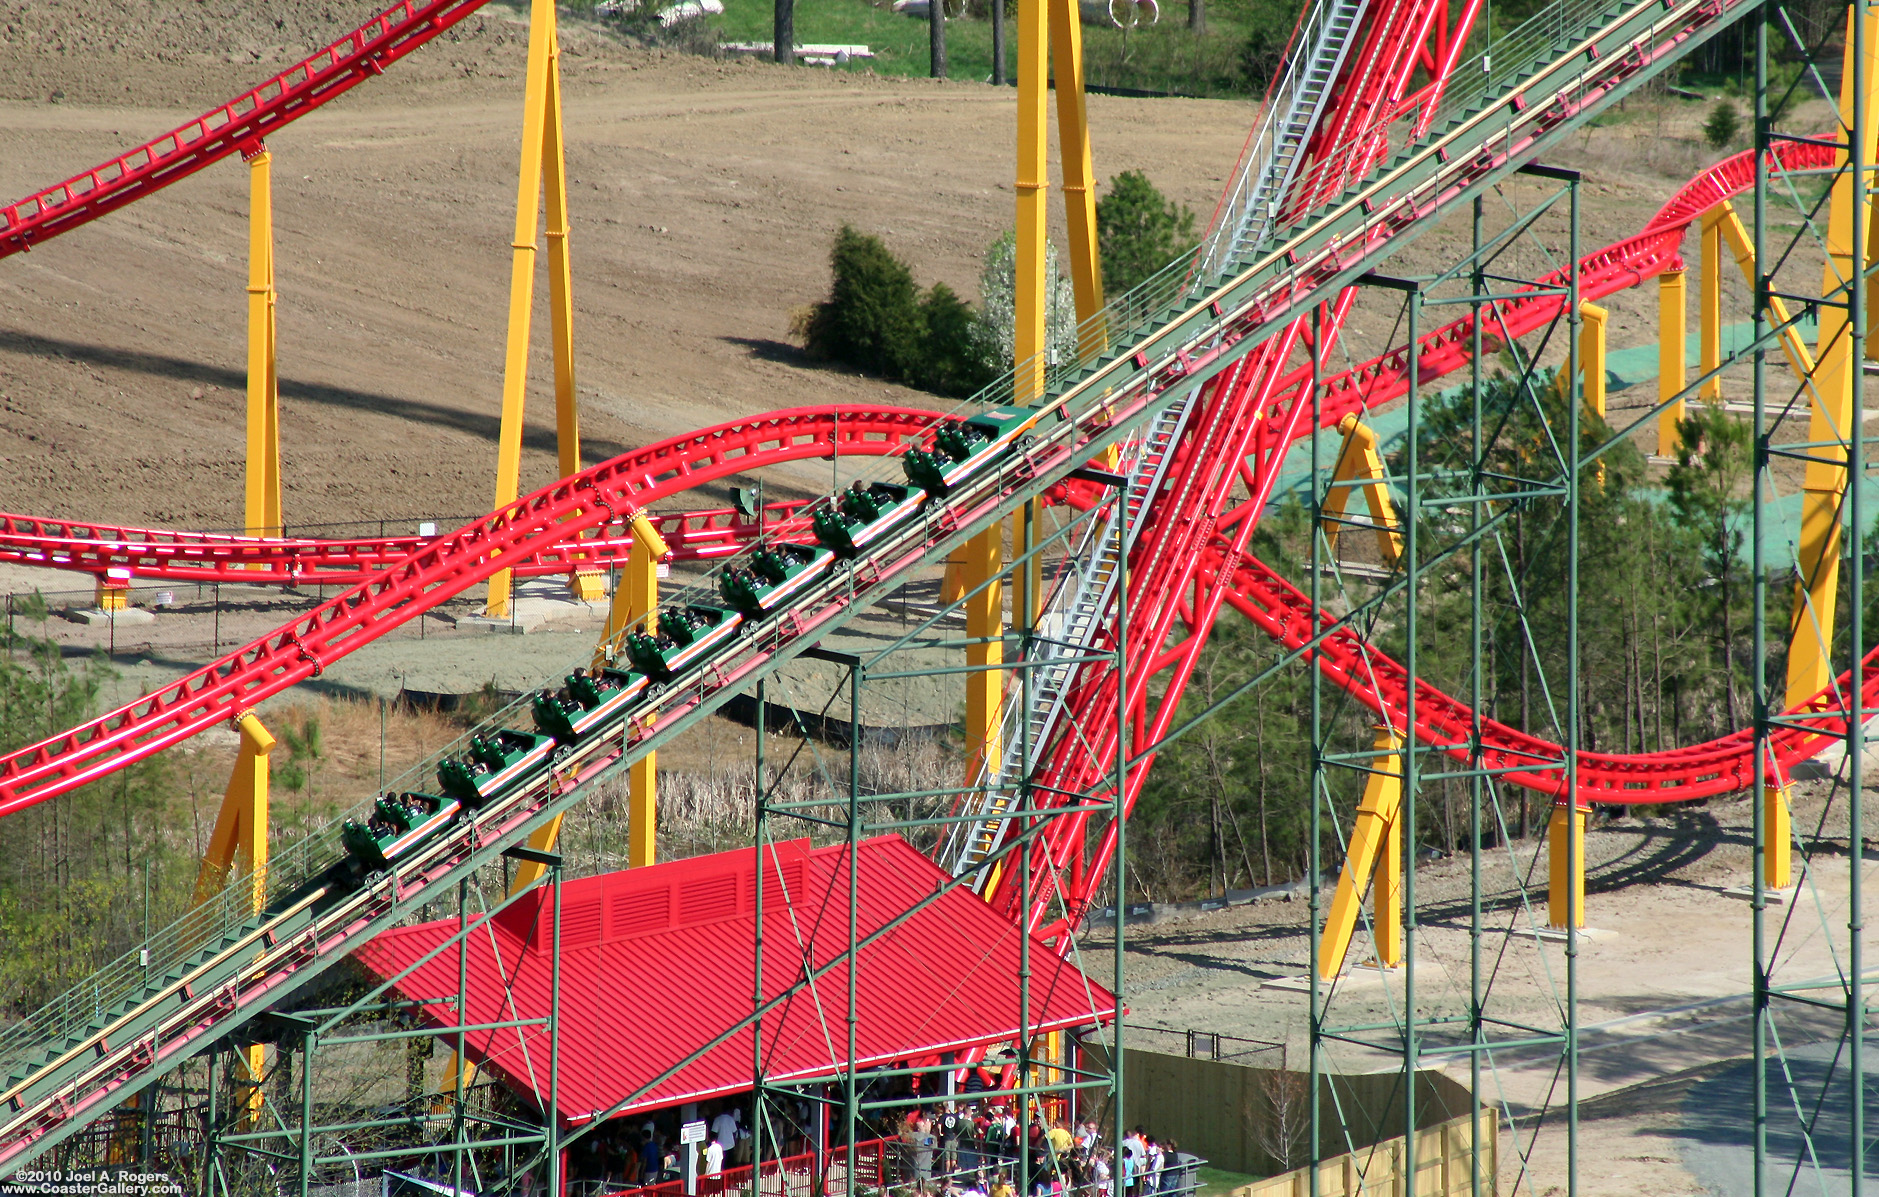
[{"left": 357, "top": 836, "right": 1114, "bottom": 1124}]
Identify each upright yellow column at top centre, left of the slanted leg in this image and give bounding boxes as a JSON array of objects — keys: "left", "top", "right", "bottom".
[{"left": 1022, "top": 0, "right": 1050, "bottom": 402}]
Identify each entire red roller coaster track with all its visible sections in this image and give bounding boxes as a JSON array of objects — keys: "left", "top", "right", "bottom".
[{"left": 0, "top": 0, "right": 1841, "bottom": 943}]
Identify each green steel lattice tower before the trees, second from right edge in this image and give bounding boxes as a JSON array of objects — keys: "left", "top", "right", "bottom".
[{"left": 1308, "top": 177, "right": 1603, "bottom": 1193}]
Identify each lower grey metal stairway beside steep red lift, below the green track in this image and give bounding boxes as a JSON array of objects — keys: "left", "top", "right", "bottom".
[{"left": 940, "top": 387, "right": 1197, "bottom": 889}]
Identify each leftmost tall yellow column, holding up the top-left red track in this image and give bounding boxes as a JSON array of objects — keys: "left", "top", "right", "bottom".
[{"left": 242, "top": 143, "right": 282, "bottom": 536}]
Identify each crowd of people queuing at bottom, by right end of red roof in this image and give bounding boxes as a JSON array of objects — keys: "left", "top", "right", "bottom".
[{"left": 891, "top": 1101, "right": 1201, "bottom": 1197}]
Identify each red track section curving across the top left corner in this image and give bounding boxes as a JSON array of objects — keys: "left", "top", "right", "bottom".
[{"left": 0, "top": 0, "right": 487, "bottom": 257}]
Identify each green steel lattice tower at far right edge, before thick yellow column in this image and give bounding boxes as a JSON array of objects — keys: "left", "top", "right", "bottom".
[{"left": 1746, "top": 0, "right": 1879, "bottom": 1193}]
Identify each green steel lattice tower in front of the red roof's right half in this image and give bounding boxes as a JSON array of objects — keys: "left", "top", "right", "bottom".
[{"left": 750, "top": 487, "right": 1129, "bottom": 1197}]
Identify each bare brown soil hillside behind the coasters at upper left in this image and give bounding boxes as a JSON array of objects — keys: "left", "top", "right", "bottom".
[{"left": 0, "top": 0, "right": 1250, "bottom": 528}]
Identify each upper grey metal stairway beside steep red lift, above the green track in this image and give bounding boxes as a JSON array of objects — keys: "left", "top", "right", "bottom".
[{"left": 1203, "top": 0, "right": 1368, "bottom": 278}]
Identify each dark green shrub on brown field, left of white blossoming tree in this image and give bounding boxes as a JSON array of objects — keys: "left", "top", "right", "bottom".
[{"left": 795, "top": 225, "right": 990, "bottom": 395}]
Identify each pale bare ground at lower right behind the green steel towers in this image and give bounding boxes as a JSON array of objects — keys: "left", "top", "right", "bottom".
[{"left": 1082, "top": 782, "right": 1875, "bottom": 1197}]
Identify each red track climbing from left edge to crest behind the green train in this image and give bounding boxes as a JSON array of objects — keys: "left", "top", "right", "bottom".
[{"left": 0, "top": 406, "right": 934, "bottom": 816}]
